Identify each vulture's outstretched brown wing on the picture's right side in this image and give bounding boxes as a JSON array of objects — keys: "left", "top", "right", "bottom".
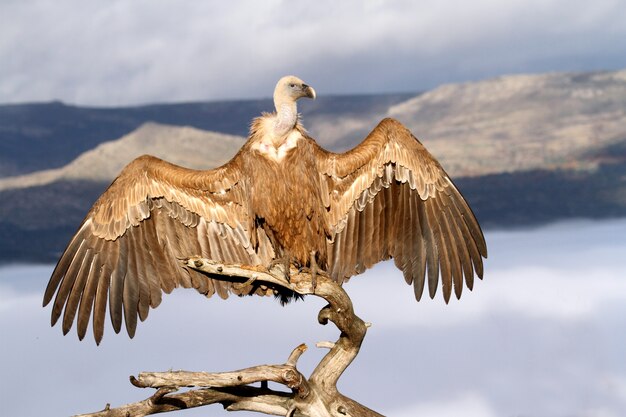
[{"left": 317, "top": 119, "right": 487, "bottom": 302}]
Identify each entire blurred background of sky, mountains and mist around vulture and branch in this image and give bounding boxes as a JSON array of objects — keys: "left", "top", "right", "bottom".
[{"left": 0, "top": 0, "right": 626, "bottom": 417}]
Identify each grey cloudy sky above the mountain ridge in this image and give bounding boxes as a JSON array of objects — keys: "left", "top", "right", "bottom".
[{"left": 0, "top": 0, "right": 626, "bottom": 105}]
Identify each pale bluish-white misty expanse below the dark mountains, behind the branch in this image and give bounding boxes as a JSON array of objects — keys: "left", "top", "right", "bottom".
[{"left": 0, "top": 219, "right": 626, "bottom": 417}]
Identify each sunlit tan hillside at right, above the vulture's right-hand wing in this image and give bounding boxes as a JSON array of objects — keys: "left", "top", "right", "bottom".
[{"left": 389, "top": 70, "right": 626, "bottom": 176}]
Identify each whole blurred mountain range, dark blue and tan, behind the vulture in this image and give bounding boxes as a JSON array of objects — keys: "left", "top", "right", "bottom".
[{"left": 0, "top": 71, "right": 626, "bottom": 261}]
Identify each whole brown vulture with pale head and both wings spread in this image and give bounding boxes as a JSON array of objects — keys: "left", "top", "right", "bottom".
[{"left": 44, "top": 77, "right": 487, "bottom": 343}]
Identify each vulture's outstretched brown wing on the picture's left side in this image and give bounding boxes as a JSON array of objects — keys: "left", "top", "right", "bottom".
[{"left": 44, "top": 156, "right": 273, "bottom": 343}]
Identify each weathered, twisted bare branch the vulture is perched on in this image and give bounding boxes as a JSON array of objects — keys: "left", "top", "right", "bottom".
[{"left": 77, "top": 257, "right": 382, "bottom": 417}]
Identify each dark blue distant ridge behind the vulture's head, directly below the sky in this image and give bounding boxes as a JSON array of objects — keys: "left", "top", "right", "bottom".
[{"left": 0, "top": 94, "right": 415, "bottom": 177}]
